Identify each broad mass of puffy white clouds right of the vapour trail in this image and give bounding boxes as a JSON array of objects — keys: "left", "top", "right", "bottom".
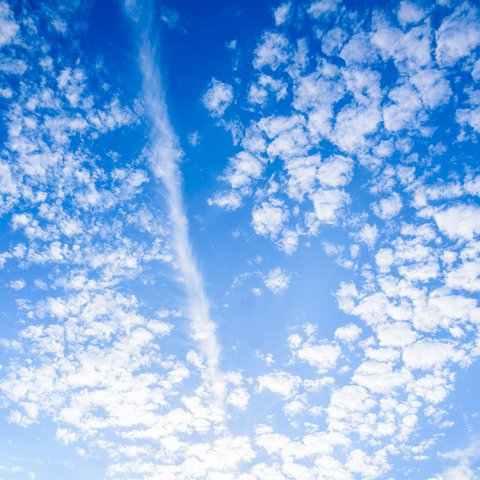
[{"left": 202, "top": 0, "right": 480, "bottom": 479}]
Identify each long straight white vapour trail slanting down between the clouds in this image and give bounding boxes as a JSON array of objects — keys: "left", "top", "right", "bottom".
[{"left": 130, "top": 5, "right": 225, "bottom": 418}]
